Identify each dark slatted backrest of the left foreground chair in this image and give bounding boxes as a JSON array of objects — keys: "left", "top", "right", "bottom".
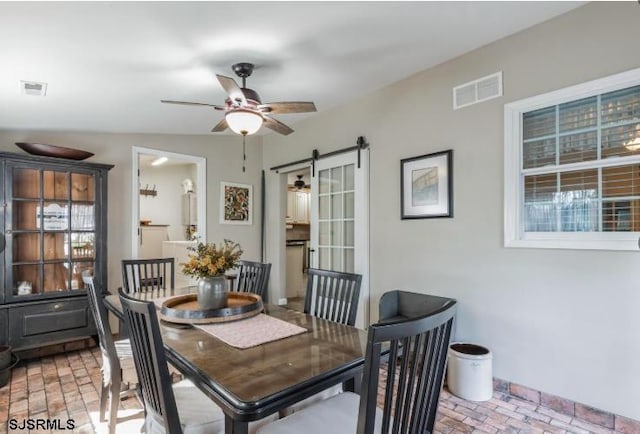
[{"left": 119, "top": 289, "right": 182, "bottom": 434}]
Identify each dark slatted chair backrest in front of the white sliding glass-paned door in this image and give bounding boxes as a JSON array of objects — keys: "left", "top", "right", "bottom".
[{"left": 304, "top": 268, "right": 362, "bottom": 326}]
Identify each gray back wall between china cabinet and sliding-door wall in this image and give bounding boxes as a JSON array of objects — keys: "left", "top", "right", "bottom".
[{"left": 0, "top": 130, "right": 262, "bottom": 289}]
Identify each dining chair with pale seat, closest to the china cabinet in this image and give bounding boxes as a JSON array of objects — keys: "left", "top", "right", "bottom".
[{"left": 82, "top": 274, "right": 138, "bottom": 434}]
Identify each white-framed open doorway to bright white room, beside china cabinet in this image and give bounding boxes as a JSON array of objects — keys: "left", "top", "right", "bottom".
[{"left": 131, "top": 147, "right": 206, "bottom": 260}]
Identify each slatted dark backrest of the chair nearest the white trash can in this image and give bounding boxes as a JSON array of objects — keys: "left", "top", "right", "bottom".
[{"left": 357, "top": 292, "right": 456, "bottom": 434}]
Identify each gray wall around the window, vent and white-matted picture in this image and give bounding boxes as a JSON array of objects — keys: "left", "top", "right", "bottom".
[{"left": 263, "top": 2, "right": 640, "bottom": 419}]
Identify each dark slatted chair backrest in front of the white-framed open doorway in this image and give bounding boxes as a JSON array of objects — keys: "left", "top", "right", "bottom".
[{"left": 122, "top": 258, "right": 176, "bottom": 294}]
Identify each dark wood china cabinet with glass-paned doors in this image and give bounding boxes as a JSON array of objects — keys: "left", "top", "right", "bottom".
[{"left": 0, "top": 153, "right": 113, "bottom": 350}]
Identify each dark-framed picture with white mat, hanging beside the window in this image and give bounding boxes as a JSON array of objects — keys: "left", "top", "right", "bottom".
[{"left": 400, "top": 149, "right": 453, "bottom": 220}]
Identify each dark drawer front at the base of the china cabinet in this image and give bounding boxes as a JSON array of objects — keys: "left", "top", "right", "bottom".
[{"left": 9, "top": 300, "right": 96, "bottom": 348}]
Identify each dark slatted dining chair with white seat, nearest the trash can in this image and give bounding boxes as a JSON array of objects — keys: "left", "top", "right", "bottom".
[{"left": 258, "top": 292, "right": 456, "bottom": 434}]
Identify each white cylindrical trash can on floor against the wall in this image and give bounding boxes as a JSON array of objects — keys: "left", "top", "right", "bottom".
[{"left": 447, "top": 342, "right": 493, "bottom": 401}]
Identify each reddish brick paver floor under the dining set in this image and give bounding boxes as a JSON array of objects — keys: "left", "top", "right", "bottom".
[{"left": 0, "top": 347, "right": 638, "bottom": 434}]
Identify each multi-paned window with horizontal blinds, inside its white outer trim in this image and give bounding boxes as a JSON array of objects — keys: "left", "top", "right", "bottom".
[{"left": 520, "top": 86, "right": 640, "bottom": 232}]
